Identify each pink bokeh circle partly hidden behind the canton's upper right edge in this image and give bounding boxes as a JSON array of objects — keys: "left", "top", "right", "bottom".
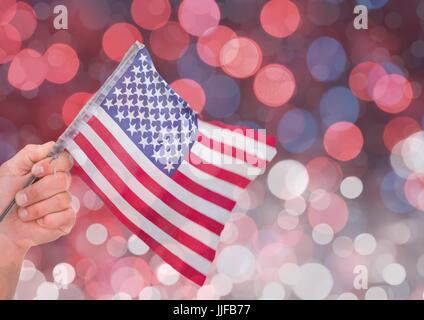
[{"left": 171, "top": 79, "right": 206, "bottom": 112}]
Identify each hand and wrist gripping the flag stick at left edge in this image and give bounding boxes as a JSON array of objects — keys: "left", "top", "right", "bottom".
[{"left": 0, "top": 142, "right": 76, "bottom": 299}]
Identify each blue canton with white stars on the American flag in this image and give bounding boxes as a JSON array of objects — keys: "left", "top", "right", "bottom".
[{"left": 101, "top": 48, "right": 197, "bottom": 175}]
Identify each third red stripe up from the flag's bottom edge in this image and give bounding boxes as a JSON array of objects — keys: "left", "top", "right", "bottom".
[{"left": 88, "top": 117, "right": 224, "bottom": 235}]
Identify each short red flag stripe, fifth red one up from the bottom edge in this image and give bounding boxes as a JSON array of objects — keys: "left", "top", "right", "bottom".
[{"left": 187, "top": 152, "right": 250, "bottom": 188}]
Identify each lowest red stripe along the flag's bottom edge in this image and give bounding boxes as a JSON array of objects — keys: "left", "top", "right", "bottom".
[{"left": 73, "top": 162, "right": 206, "bottom": 286}]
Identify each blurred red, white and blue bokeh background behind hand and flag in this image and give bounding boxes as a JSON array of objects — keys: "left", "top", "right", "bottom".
[{"left": 0, "top": 0, "right": 424, "bottom": 299}]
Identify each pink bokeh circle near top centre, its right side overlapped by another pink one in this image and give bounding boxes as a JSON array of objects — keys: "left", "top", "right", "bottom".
[{"left": 197, "top": 26, "right": 237, "bottom": 67}]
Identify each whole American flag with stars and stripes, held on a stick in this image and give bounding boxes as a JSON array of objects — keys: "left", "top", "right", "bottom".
[{"left": 61, "top": 43, "right": 276, "bottom": 285}]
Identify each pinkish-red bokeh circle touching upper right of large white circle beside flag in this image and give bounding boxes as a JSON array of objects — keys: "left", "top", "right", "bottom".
[{"left": 306, "top": 157, "right": 343, "bottom": 191}]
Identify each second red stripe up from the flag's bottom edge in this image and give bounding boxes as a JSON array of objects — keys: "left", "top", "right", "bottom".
[{"left": 74, "top": 133, "right": 215, "bottom": 261}]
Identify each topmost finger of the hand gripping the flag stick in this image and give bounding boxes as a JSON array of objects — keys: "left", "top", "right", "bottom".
[{"left": 8, "top": 141, "right": 54, "bottom": 175}]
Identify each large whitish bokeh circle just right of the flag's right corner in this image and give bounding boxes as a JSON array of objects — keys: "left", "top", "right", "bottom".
[{"left": 268, "top": 160, "right": 309, "bottom": 200}]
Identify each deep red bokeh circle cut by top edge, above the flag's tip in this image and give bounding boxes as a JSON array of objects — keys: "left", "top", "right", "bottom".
[{"left": 131, "top": 0, "right": 171, "bottom": 30}]
